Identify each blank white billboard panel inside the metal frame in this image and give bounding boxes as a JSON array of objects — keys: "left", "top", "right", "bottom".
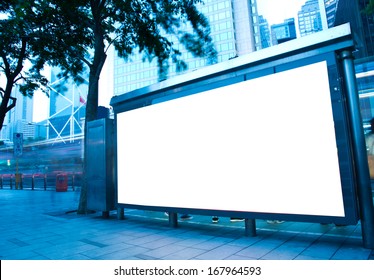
[{"left": 117, "top": 62, "right": 345, "bottom": 217}]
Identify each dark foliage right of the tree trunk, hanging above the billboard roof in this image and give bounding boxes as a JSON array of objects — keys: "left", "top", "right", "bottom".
[{"left": 111, "top": 0, "right": 217, "bottom": 79}]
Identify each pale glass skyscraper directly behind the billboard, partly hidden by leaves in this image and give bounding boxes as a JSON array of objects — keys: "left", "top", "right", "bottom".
[{"left": 114, "top": 0, "right": 262, "bottom": 95}]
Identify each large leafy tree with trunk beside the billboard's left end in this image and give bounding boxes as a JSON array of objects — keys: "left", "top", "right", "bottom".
[{"left": 46, "top": 0, "right": 216, "bottom": 213}]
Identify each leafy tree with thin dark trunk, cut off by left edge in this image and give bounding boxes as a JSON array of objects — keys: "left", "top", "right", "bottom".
[{"left": 0, "top": 0, "right": 48, "bottom": 130}]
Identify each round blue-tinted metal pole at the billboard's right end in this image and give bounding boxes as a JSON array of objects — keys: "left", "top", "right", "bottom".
[{"left": 340, "top": 50, "right": 374, "bottom": 249}]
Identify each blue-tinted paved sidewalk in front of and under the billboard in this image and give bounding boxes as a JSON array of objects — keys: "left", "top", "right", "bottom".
[{"left": 0, "top": 189, "right": 374, "bottom": 260}]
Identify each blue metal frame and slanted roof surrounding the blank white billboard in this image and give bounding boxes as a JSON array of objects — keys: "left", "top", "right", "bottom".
[{"left": 111, "top": 24, "right": 372, "bottom": 247}]
